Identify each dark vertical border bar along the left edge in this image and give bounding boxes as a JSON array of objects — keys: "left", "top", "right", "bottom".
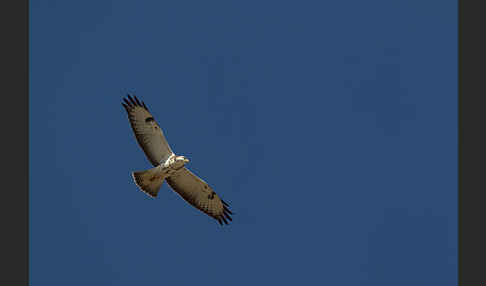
[{"left": 0, "top": 0, "right": 29, "bottom": 285}]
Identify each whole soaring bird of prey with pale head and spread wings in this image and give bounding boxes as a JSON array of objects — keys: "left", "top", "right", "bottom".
[{"left": 122, "top": 95, "right": 232, "bottom": 225}]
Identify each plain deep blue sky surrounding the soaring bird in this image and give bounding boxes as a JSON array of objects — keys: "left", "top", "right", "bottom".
[{"left": 30, "top": 0, "right": 457, "bottom": 286}]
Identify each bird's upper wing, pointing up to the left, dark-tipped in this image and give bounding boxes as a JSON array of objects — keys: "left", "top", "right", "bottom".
[{"left": 122, "top": 95, "right": 173, "bottom": 166}]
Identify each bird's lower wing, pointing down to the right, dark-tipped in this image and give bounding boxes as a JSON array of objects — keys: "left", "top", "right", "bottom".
[{"left": 166, "top": 167, "right": 233, "bottom": 224}]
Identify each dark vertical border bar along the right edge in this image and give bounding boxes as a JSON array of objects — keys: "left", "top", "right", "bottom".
[{"left": 458, "top": 0, "right": 486, "bottom": 286}]
